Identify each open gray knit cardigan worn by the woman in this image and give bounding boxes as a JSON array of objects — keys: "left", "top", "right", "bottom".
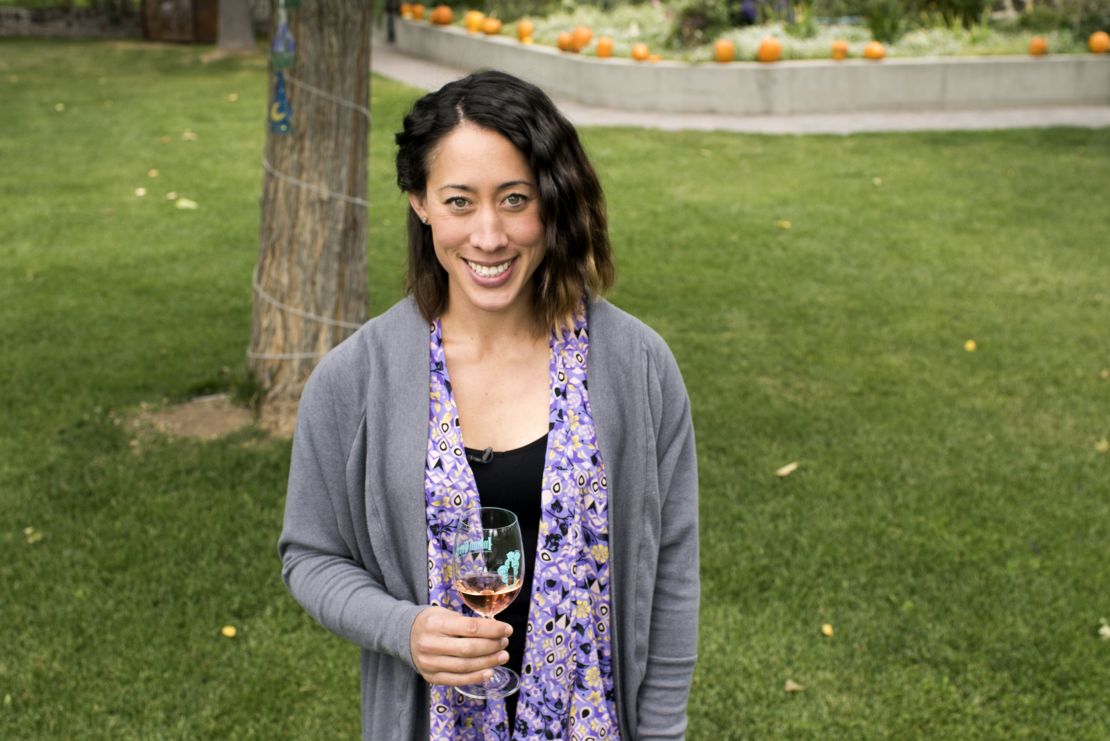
[{"left": 279, "top": 298, "right": 699, "bottom": 741}]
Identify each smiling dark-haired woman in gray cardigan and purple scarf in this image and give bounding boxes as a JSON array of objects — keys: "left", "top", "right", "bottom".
[{"left": 280, "top": 72, "right": 698, "bottom": 741}]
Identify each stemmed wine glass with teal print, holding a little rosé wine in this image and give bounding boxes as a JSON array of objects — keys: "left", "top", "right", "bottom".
[{"left": 452, "top": 507, "right": 524, "bottom": 699}]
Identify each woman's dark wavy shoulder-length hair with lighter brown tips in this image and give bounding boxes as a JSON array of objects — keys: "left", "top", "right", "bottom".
[{"left": 395, "top": 71, "right": 616, "bottom": 328}]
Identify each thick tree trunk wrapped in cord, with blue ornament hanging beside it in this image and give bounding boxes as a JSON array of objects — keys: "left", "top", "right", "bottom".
[{"left": 248, "top": 0, "right": 371, "bottom": 434}]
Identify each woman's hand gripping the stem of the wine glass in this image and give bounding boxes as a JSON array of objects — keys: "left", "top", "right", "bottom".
[{"left": 408, "top": 607, "right": 513, "bottom": 687}]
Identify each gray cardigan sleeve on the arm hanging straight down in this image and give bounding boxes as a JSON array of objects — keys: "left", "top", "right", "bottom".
[{"left": 635, "top": 341, "right": 700, "bottom": 741}]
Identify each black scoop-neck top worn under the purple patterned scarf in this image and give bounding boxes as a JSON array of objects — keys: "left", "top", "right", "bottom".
[{"left": 466, "top": 435, "right": 547, "bottom": 728}]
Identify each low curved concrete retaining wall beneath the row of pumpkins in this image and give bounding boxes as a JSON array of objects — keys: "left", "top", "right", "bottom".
[{"left": 396, "top": 20, "right": 1110, "bottom": 115}]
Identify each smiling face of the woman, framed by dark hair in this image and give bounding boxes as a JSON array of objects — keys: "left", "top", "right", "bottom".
[{"left": 408, "top": 122, "right": 545, "bottom": 321}]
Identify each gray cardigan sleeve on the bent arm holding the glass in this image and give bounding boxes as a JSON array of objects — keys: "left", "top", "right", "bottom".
[{"left": 279, "top": 355, "right": 425, "bottom": 667}]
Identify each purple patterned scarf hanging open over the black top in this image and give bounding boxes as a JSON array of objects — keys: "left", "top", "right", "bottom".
[{"left": 424, "top": 303, "right": 620, "bottom": 741}]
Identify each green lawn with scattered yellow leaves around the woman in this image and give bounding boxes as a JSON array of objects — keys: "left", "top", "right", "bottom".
[{"left": 0, "top": 41, "right": 1110, "bottom": 740}]
